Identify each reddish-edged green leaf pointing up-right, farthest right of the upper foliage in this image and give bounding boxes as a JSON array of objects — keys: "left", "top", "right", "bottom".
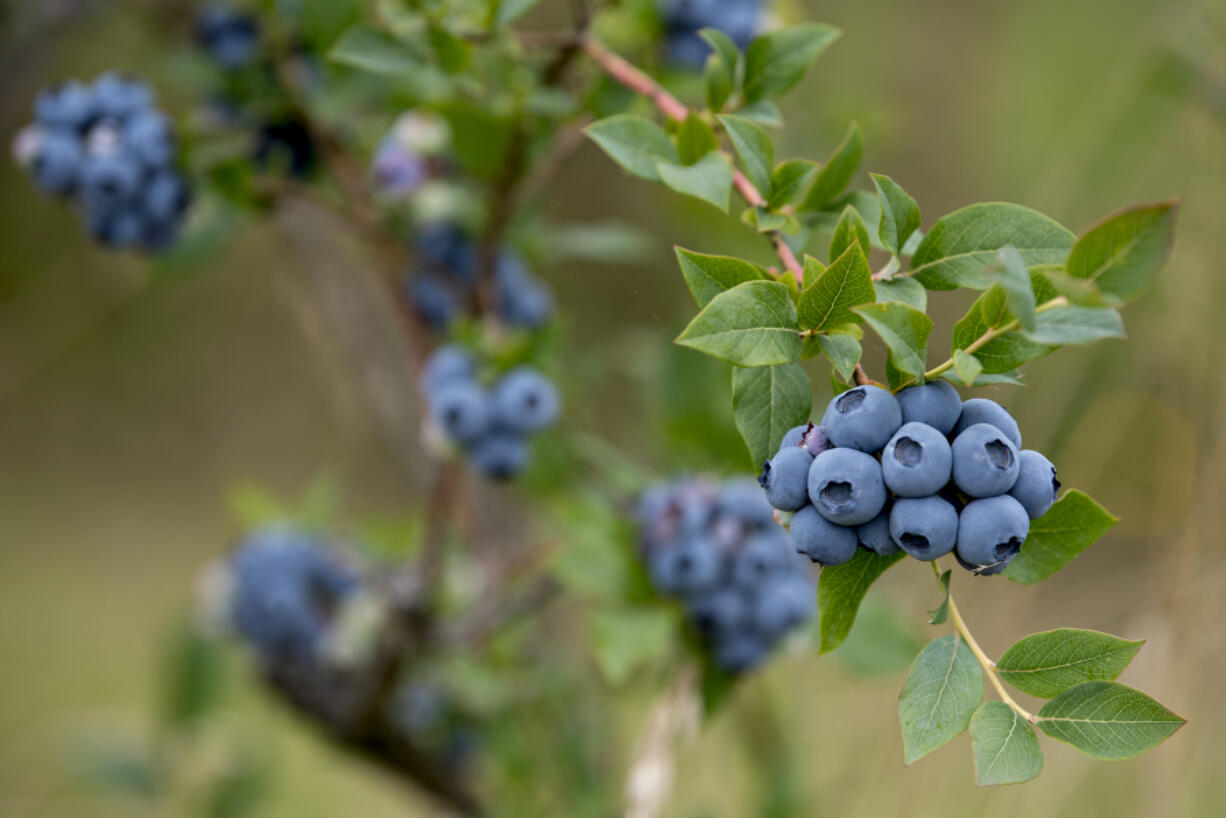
[{"left": 1067, "top": 201, "right": 1179, "bottom": 300}]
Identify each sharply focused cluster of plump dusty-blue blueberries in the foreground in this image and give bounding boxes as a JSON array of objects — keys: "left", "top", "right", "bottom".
[{"left": 759, "top": 381, "right": 1059, "bottom": 574}]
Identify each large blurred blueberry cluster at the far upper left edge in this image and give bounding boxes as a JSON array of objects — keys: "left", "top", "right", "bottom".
[{"left": 13, "top": 72, "right": 190, "bottom": 250}]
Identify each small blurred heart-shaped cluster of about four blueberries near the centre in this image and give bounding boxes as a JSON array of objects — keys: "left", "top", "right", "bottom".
[{"left": 422, "top": 346, "right": 562, "bottom": 480}]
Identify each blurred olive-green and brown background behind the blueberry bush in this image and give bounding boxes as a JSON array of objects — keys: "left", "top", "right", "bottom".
[{"left": 0, "top": 0, "right": 1226, "bottom": 818}]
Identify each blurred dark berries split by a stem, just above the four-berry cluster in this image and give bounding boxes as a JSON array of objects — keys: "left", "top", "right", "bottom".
[{"left": 406, "top": 224, "right": 554, "bottom": 331}]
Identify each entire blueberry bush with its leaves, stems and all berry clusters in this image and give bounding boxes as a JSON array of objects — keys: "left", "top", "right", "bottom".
[{"left": 15, "top": 0, "right": 1183, "bottom": 816}]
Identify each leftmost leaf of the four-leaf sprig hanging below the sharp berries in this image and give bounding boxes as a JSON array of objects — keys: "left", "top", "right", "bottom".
[{"left": 899, "top": 634, "right": 983, "bottom": 764}]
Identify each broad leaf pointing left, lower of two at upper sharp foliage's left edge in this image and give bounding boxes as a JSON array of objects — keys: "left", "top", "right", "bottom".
[{"left": 677, "top": 281, "right": 802, "bottom": 367}]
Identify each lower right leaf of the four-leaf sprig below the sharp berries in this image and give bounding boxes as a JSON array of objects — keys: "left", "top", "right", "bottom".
[{"left": 1038, "top": 682, "right": 1187, "bottom": 760}]
